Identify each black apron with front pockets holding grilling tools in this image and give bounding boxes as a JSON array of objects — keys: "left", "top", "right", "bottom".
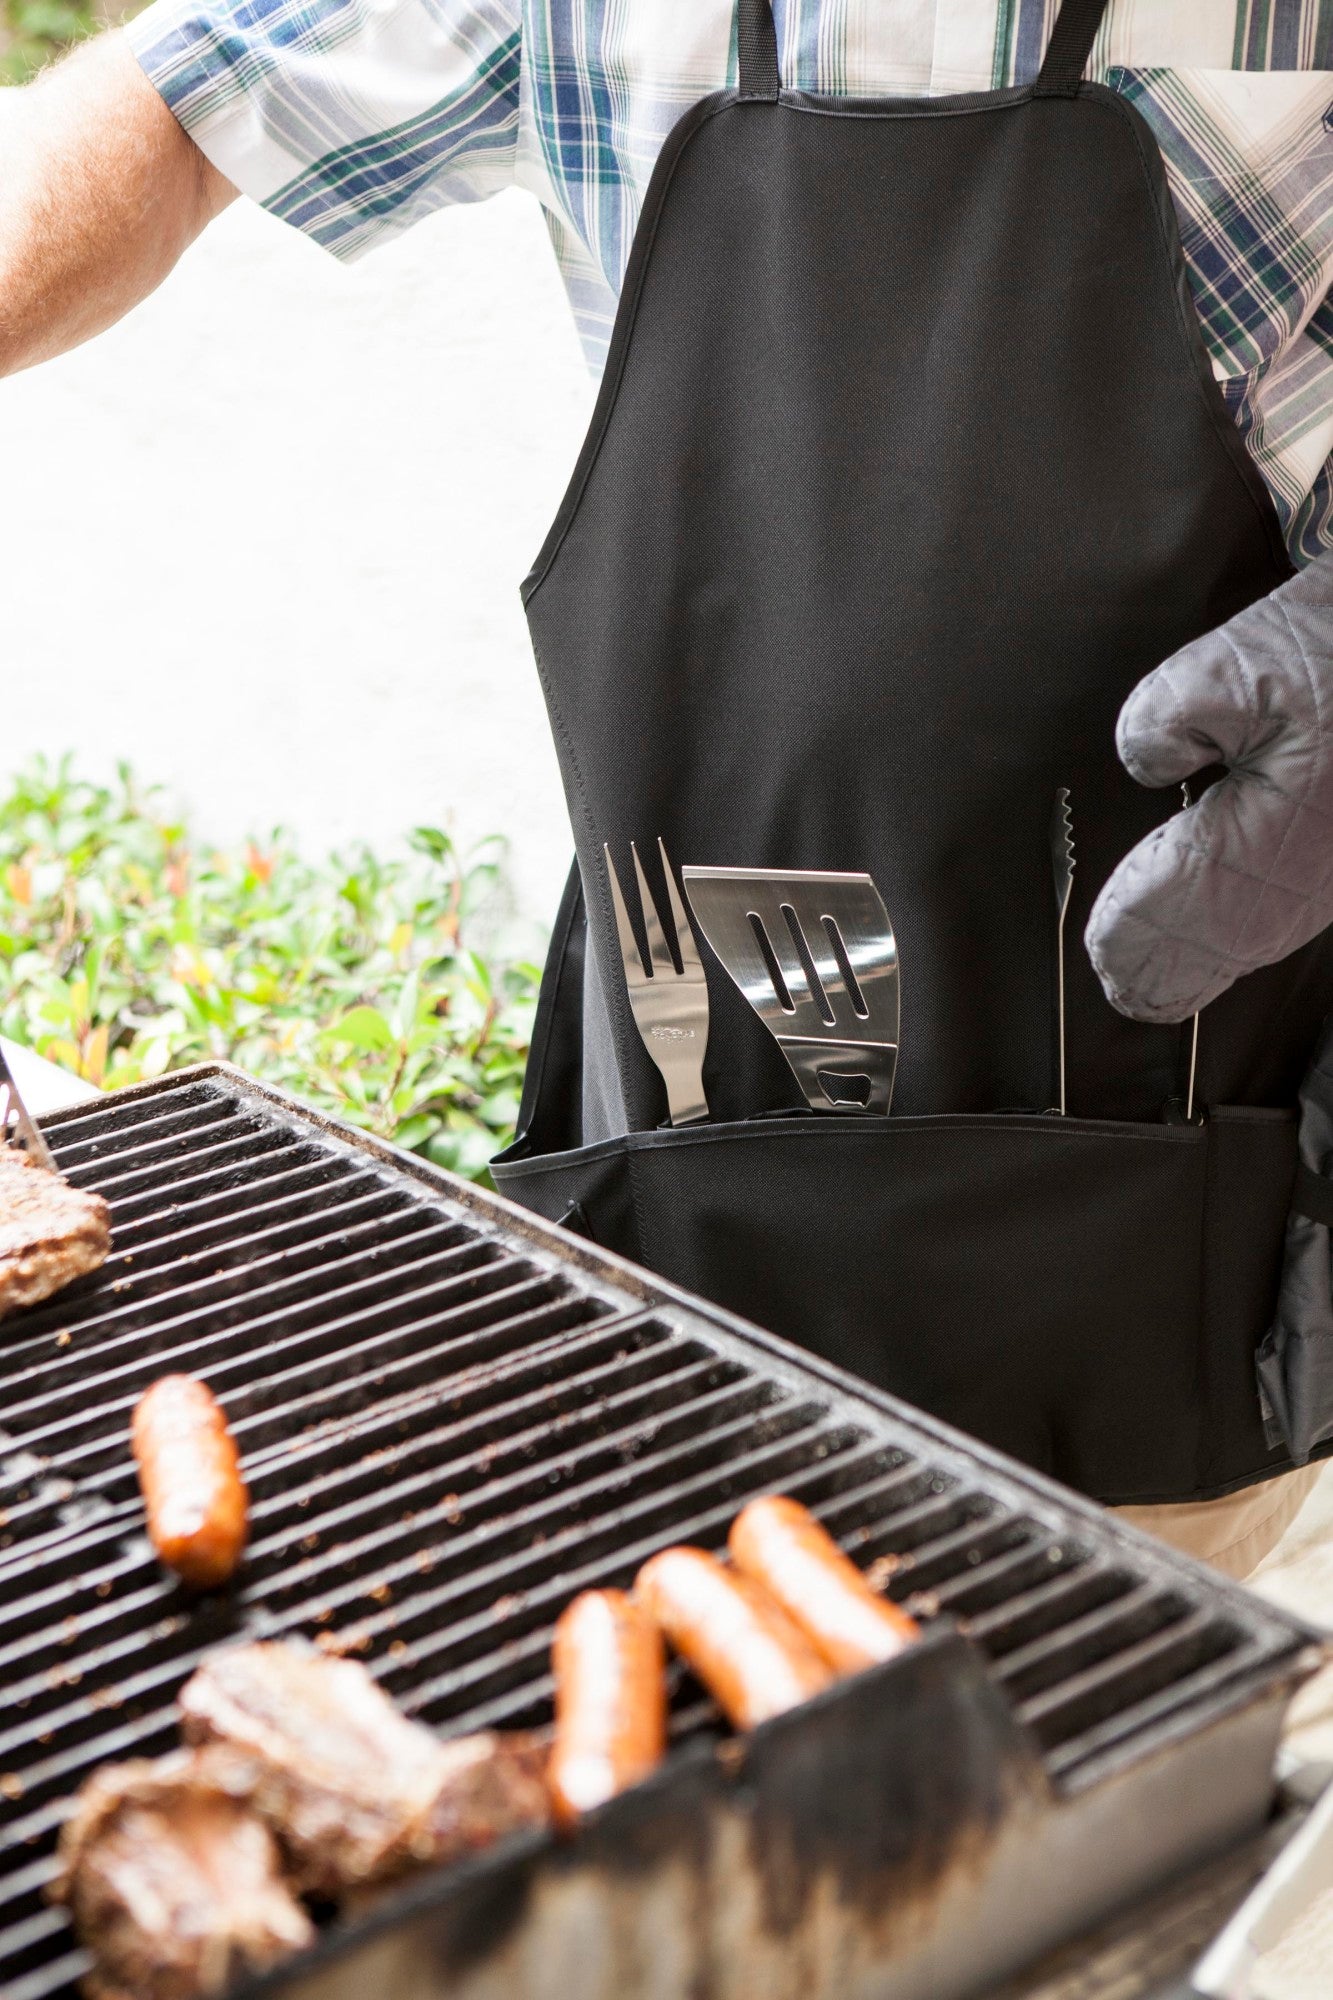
[{"left": 494, "top": 0, "right": 1333, "bottom": 1502}]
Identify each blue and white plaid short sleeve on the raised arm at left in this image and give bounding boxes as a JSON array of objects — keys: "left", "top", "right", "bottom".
[{"left": 126, "top": 0, "right": 522, "bottom": 258}]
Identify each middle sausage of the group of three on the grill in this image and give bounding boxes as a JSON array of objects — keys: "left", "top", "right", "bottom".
[{"left": 634, "top": 1548, "right": 833, "bottom": 1730}]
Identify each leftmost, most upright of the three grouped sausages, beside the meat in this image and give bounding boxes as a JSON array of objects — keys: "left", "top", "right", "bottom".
[{"left": 546, "top": 1590, "right": 667, "bottom": 1826}]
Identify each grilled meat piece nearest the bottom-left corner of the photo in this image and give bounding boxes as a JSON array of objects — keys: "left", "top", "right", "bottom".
[{"left": 52, "top": 1750, "right": 314, "bottom": 2000}]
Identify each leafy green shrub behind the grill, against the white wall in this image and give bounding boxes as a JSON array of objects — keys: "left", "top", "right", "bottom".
[{"left": 0, "top": 760, "right": 538, "bottom": 1178}]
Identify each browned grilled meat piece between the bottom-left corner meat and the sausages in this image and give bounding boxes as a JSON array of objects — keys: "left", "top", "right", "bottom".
[{"left": 180, "top": 1644, "right": 548, "bottom": 1898}]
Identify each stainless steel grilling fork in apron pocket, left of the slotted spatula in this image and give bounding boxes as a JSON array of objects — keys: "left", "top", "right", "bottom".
[{"left": 602, "top": 840, "right": 709, "bottom": 1124}]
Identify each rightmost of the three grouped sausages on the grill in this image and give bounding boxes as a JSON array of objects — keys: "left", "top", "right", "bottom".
[{"left": 727, "top": 1494, "right": 921, "bottom": 1674}]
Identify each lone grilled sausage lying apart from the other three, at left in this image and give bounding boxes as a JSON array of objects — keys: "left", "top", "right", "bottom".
[{"left": 130, "top": 1376, "right": 248, "bottom": 1590}]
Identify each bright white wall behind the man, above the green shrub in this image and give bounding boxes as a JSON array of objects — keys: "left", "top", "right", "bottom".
[{"left": 0, "top": 194, "right": 590, "bottom": 918}]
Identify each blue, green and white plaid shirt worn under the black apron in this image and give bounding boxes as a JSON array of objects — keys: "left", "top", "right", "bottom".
[{"left": 128, "top": 0, "right": 1333, "bottom": 562}]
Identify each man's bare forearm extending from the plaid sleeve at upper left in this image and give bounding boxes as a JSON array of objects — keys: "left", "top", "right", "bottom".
[{"left": 0, "top": 34, "right": 236, "bottom": 376}]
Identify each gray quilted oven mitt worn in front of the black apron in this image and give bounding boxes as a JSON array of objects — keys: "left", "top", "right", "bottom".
[{"left": 1085, "top": 554, "right": 1333, "bottom": 1022}]
